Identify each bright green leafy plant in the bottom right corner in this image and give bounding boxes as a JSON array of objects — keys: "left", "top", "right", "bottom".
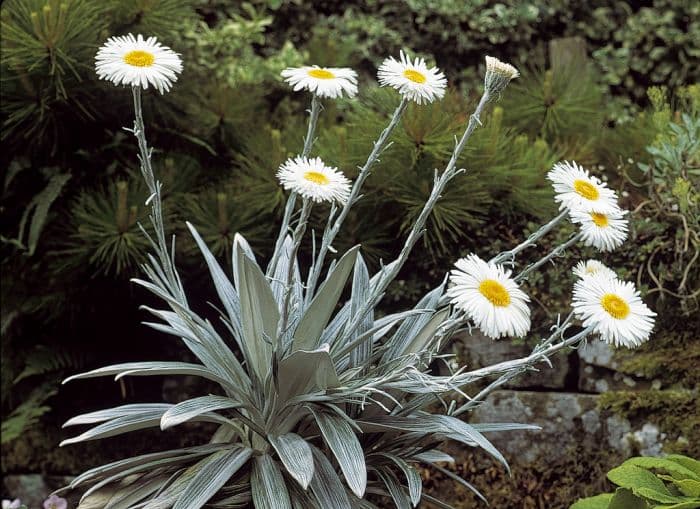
[{"left": 571, "top": 454, "right": 700, "bottom": 509}]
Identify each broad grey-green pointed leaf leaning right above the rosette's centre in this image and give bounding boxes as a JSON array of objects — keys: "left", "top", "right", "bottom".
[{"left": 293, "top": 246, "right": 360, "bottom": 350}]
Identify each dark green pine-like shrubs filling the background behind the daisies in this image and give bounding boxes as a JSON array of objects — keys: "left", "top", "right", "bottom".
[{"left": 0, "top": 0, "right": 700, "bottom": 507}]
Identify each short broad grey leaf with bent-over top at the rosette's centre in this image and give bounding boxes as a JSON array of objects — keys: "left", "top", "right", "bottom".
[{"left": 277, "top": 345, "right": 338, "bottom": 401}]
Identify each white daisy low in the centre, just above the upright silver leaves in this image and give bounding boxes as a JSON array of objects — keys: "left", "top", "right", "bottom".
[{"left": 277, "top": 157, "right": 350, "bottom": 203}]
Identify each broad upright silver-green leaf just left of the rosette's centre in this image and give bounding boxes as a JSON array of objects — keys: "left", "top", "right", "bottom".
[{"left": 236, "top": 242, "right": 279, "bottom": 380}]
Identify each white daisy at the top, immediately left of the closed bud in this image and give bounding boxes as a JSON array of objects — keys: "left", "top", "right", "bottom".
[{"left": 377, "top": 51, "right": 447, "bottom": 104}]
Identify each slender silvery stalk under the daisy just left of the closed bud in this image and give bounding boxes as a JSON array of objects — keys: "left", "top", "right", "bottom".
[{"left": 304, "top": 97, "right": 409, "bottom": 306}]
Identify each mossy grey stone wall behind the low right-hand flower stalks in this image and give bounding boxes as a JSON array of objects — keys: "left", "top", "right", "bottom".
[{"left": 454, "top": 333, "right": 666, "bottom": 463}]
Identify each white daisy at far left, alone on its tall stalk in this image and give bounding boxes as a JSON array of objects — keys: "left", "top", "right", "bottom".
[{"left": 95, "top": 34, "right": 182, "bottom": 94}]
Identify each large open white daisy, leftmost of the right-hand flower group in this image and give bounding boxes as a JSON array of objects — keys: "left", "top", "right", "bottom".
[{"left": 447, "top": 254, "right": 530, "bottom": 339}]
